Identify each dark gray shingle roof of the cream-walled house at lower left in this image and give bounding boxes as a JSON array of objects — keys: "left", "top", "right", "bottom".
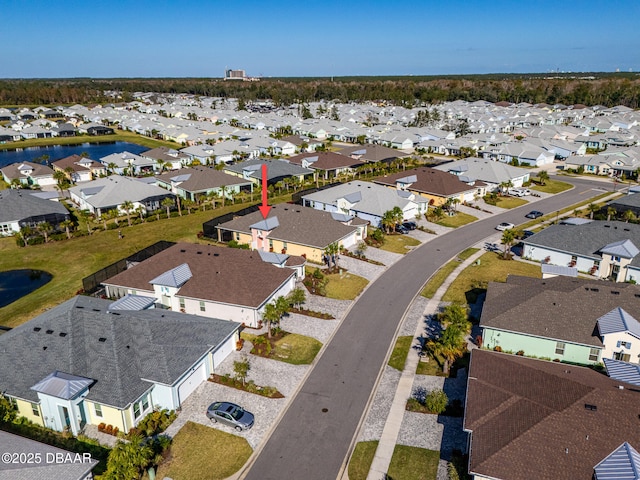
[{"left": 0, "top": 296, "right": 240, "bottom": 408}]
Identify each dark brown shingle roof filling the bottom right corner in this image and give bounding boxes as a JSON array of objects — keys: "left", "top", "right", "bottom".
[{"left": 464, "top": 350, "right": 640, "bottom": 480}]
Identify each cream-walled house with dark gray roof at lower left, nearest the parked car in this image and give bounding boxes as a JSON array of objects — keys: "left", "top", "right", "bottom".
[{"left": 0, "top": 296, "right": 241, "bottom": 435}]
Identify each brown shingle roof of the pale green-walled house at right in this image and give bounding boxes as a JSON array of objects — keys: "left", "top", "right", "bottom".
[{"left": 480, "top": 275, "right": 640, "bottom": 346}]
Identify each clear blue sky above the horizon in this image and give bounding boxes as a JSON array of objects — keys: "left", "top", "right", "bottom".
[{"left": 0, "top": 0, "right": 640, "bottom": 78}]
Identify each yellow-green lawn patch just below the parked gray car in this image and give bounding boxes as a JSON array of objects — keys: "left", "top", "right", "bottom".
[{"left": 156, "top": 422, "right": 253, "bottom": 480}]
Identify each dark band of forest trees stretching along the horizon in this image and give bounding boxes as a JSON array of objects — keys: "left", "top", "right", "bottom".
[{"left": 0, "top": 73, "right": 640, "bottom": 108}]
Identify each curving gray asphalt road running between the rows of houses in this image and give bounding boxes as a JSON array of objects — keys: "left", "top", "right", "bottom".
[{"left": 241, "top": 178, "right": 612, "bottom": 480}]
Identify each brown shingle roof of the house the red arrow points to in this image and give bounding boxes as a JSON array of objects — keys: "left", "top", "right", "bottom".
[{"left": 217, "top": 204, "right": 361, "bottom": 249}]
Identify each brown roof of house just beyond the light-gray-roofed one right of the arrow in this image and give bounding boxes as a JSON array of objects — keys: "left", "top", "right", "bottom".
[{"left": 374, "top": 167, "right": 485, "bottom": 197}]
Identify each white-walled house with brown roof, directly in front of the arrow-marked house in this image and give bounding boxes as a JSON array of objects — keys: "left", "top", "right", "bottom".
[{"left": 103, "top": 243, "right": 300, "bottom": 328}]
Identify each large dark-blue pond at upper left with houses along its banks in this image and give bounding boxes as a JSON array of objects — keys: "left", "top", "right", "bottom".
[{"left": 0, "top": 142, "right": 149, "bottom": 167}]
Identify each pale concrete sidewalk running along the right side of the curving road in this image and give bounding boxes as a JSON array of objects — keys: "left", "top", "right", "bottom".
[{"left": 367, "top": 242, "right": 486, "bottom": 480}]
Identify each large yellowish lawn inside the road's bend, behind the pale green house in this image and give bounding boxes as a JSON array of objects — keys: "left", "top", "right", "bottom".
[{"left": 442, "top": 252, "right": 541, "bottom": 303}]
